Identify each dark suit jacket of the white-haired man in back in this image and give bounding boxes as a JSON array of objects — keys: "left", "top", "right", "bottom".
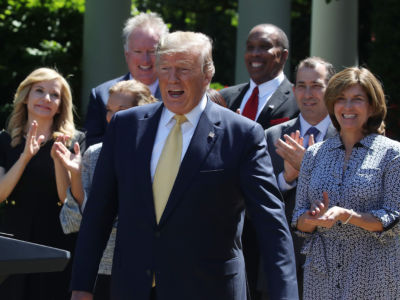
[{"left": 84, "top": 73, "right": 161, "bottom": 147}]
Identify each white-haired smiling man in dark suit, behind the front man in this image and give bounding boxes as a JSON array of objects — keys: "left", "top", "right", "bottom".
[{"left": 84, "top": 13, "right": 168, "bottom": 146}]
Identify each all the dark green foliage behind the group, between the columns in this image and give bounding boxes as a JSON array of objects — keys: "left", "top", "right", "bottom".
[{"left": 0, "top": 0, "right": 400, "bottom": 139}]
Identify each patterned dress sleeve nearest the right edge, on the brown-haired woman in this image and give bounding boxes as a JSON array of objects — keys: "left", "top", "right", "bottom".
[{"left": 370, "top": 155, "right": 400, "bottom": 240}]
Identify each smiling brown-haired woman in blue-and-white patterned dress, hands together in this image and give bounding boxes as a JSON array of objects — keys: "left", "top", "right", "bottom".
[{"left": 292, "top": 67, "right": 400, "bottom": 300}]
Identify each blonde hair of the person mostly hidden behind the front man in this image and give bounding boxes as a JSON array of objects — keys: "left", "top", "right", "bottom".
[{"left": 109, "top": 79, "right": 157, "bottom": 106}]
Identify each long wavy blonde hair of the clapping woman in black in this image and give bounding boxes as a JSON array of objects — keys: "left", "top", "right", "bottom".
[{"left": 7, "top": 68, "right": 75, "bottom": 147}]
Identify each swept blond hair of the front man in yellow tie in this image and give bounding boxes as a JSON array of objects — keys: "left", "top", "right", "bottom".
[{"left": 156, "top": 31, "right": 215, "bottom": 77}]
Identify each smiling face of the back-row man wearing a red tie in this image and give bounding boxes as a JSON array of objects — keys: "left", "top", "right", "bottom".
[{"left": 244, "top": 26, "right": 288, "bottom": 84}]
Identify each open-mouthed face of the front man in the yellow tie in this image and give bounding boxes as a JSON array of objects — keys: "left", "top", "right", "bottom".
[{"left": 157, "top": 49, "right": 211, "bottom": 115}]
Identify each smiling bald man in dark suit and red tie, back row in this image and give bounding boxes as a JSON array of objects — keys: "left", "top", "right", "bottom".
[{"left": 220, "top": 24, "right": 299, "bottom": 300}]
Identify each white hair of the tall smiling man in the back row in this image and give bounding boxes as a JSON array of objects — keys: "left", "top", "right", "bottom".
[{"left": 122, "top": 12, "right": 169, "bottom": 51}]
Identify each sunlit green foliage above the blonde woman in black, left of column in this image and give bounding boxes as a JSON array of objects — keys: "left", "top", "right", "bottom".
[{"left": 0, "top": 0, "right": 85, "bottom": 128}]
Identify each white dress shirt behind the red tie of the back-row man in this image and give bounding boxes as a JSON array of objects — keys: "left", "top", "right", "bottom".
[{"left": 240, "top": 72, "right": 285, "bottom": 120}]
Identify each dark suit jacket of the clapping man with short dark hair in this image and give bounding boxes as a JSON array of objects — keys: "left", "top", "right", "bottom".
[{"left": 262, "top": 117, "right": 337, "bottom": 292}]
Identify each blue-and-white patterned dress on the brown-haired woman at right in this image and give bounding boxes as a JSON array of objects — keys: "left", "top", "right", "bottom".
[{"left": 292, "top": 134, "right": 400, "bottom": 300}]
